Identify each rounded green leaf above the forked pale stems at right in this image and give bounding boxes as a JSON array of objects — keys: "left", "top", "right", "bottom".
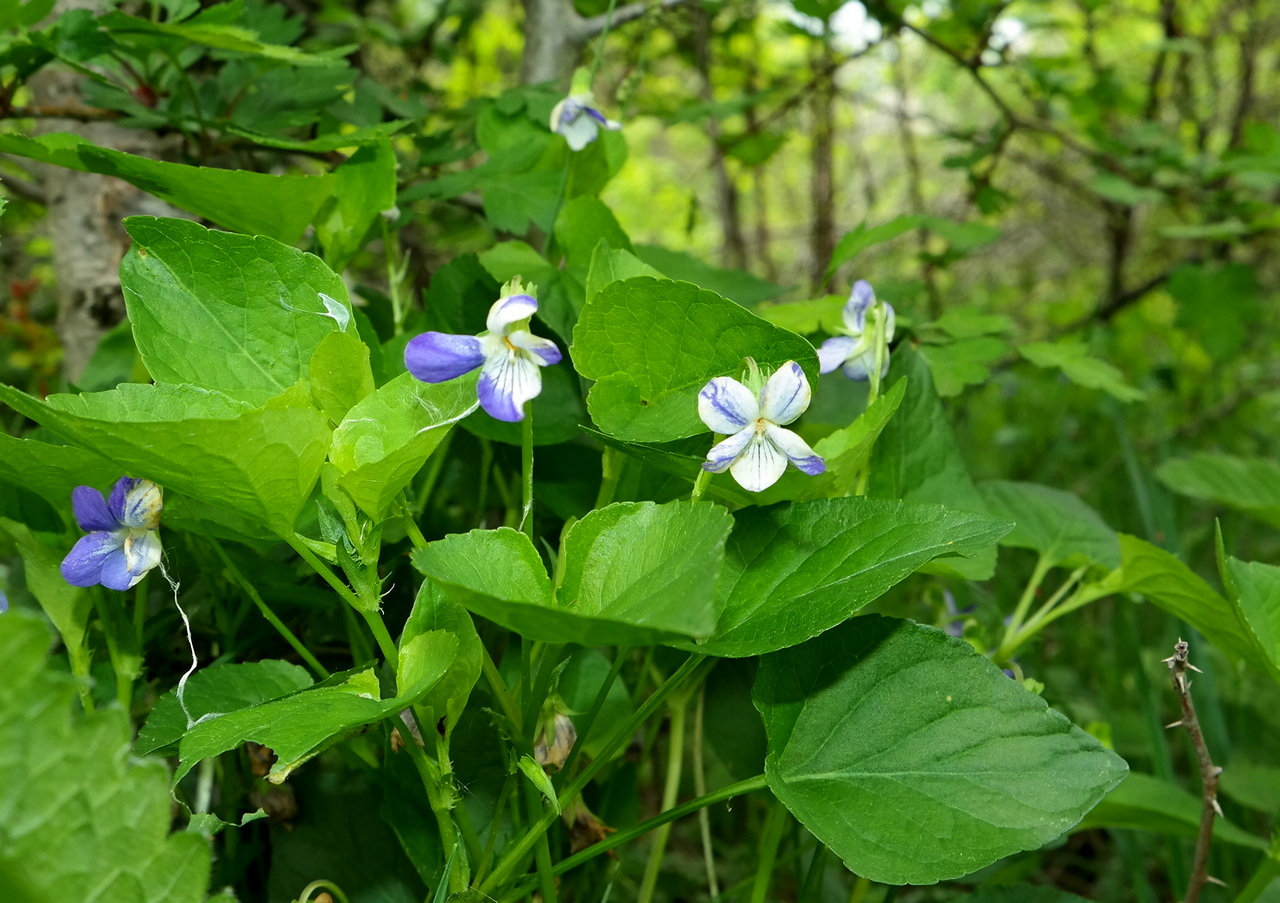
[{"left": 978, "top": 480, "right": 1120, "bottom": 570}]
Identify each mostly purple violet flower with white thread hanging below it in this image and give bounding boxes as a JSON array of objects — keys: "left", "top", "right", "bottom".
[{"left": 61, "top": 476, "right": 164, "bottom": 590}]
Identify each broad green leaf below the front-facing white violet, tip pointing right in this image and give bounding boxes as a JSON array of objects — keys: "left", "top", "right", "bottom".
[{"left": 686, "top": 498, "right": 1010, "bottom": 657}]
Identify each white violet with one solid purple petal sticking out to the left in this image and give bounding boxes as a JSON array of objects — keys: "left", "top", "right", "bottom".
[{"left": 404, "top": 279, "right": 561, "bottom": 423}]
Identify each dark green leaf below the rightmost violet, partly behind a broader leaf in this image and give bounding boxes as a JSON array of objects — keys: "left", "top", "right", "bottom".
[{"left": 867, "top": 347, "right": 996, "bottom": 580}]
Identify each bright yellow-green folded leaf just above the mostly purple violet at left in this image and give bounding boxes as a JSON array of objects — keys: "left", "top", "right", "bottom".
[{"left": 0, "top": 383, "right": 329, "bottom": 533}]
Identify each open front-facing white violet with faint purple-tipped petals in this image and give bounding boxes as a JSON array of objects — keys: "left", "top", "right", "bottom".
[{"left": 698, "top": 361, "right": 827, "bottom": 492}]
